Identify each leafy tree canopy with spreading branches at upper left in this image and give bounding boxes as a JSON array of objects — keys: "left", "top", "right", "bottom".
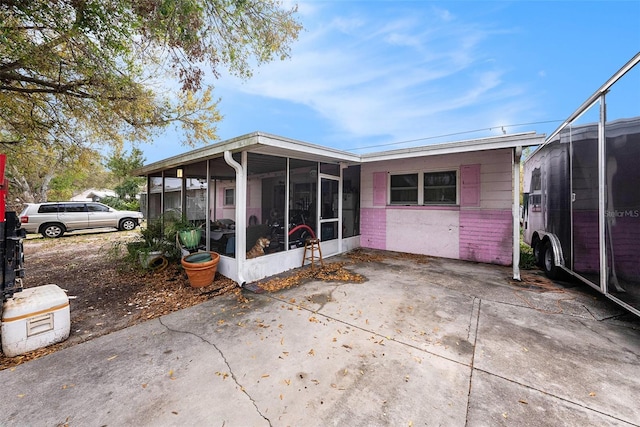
[{"left": 0, "top": 0, "right": 301, "bottom": 204}]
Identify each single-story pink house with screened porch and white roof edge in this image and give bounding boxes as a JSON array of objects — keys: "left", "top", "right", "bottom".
[{"left": 136, "top": 132, "right": 544, "bottom": 285}]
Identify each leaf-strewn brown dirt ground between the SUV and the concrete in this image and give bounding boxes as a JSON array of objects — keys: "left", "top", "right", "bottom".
[{"left": 0, "top": 229, "right": 238, "bottom": 369}]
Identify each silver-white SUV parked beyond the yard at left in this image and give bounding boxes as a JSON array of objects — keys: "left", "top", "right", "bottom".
[{"left": 20, "top": 202, "right": 142, "bottom": 237}]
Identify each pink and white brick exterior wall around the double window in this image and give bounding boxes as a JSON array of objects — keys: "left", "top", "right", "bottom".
[{"left": 360, "top": 149, "right": 513, "bottom": 265}]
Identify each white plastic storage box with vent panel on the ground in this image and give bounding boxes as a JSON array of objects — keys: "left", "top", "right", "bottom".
[{"left": 1, "top": 285, "right": 71, "bottom": 357}]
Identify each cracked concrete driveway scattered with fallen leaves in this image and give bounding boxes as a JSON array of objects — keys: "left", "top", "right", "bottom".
[{"left": 0, "top": 252, "right": 640, "bottom": 426}]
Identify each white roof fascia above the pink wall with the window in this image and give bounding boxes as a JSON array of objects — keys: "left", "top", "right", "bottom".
[{"left": 361, "top": 132, "right": 545, "bottom": 163}]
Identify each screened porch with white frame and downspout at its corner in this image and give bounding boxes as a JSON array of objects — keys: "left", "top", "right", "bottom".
[{"left": 137, "top": 133, "right": 360, "bottom": 284}]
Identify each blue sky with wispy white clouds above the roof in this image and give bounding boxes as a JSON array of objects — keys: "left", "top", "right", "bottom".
[{"left": 142, "top": 0, "right": 640, "bottom": 163}]
